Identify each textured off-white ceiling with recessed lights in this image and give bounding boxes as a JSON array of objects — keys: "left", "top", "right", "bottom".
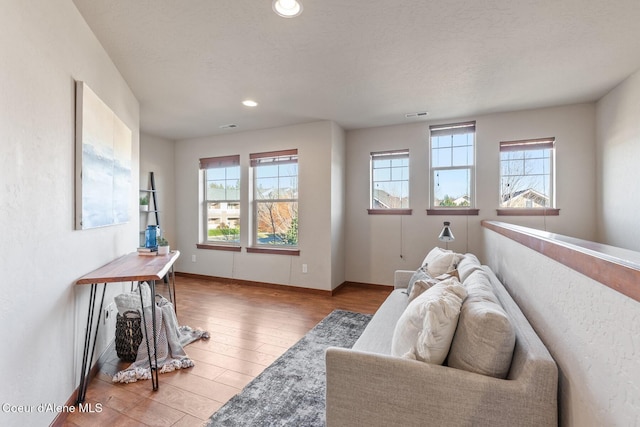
[{"left": 74, "top": 0, "right": 640, "bottom": 140}]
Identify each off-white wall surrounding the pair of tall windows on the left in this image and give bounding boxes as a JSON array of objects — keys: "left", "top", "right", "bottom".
[{"left": 175, "top": 121, "right": 341, "bottom": 290}]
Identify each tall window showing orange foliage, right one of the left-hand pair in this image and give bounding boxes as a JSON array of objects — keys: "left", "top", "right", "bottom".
[{"left": 250, "top": 150, "right": 298, "bottom": 248}]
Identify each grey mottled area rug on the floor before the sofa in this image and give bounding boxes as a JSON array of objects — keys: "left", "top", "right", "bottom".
[{"left": 205, "top": 310, "right": 371, "bottom": 426}]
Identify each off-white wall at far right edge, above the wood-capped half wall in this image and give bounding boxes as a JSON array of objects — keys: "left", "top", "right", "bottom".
[{"left": 597, "top": 70, "right": 640, "bottom": 251}]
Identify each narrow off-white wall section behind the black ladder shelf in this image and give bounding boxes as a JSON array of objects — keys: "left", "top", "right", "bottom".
[{"left": 138, "top": 133, "right": 180, "bottom": 249}]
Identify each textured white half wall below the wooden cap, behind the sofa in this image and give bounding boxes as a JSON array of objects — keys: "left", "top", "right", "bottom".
[{"left": 483, "top": 229, "right": 640, "bottom": 427}]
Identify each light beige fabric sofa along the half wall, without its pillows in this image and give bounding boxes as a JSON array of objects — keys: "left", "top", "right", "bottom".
[{"left": 326, "top": 254, "right": 558, "bottom": 427}]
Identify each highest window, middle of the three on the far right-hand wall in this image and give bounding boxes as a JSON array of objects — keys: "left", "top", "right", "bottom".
[{"left": 428, "top": 122, "right": 476, "bottom": 214}]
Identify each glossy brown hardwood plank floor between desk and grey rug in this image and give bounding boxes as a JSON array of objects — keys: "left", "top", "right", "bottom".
[{"left": 63, "top": 275, "right": 391, "bottom": 427}]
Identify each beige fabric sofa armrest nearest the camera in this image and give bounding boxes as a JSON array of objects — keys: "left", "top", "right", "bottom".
[{"left": 326, "top": 347, "right": 557, "bottom": 427}]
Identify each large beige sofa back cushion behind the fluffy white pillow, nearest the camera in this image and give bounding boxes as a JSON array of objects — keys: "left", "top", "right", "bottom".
[{"left": 447, "top": 270, "right": 516, "bottom": 379}]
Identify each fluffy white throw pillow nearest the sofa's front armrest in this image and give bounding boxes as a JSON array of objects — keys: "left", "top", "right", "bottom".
[{"left": 391, "top": 278, "right": 467, "bottom": 365}]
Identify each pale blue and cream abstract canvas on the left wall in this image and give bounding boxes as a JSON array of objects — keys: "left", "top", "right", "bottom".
[{"left": 75, "top": 81, "right": 132, "bottom": 230}]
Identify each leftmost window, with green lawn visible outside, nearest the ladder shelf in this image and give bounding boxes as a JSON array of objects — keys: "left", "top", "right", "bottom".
[{"left": 200, "top": 156, "right": 240, "bottom": 245}]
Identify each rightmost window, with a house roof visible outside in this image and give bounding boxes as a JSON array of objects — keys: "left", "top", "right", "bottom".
[{"left": 500, "top": 138, "right": 555, "bottom": 209}]
